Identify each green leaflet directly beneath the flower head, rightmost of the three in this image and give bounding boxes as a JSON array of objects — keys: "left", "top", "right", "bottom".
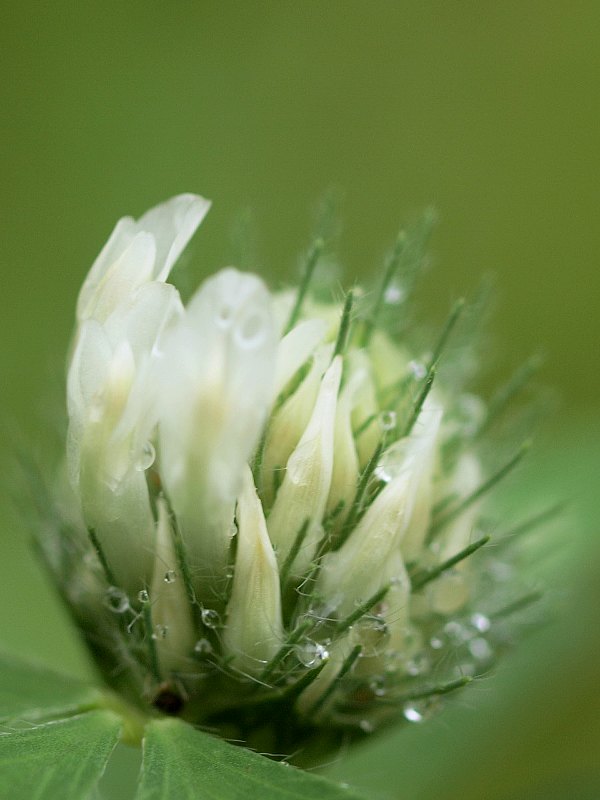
[{"left": 136, "top": 719, "right": 366, "bottom": 800}]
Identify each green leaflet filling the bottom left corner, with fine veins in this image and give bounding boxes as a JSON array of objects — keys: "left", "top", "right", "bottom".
[{"left": 0, "top": 711, "right": 121, "bottom": 800}]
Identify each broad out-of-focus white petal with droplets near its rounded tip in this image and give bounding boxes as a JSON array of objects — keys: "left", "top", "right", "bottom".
[{"left": 158, "top": 269, "right": 276, "bottom": 592}]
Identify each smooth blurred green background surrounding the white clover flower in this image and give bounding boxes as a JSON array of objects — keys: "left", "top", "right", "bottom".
[{"left": 0, "top": 0, "right": 600, "bottom": 798}]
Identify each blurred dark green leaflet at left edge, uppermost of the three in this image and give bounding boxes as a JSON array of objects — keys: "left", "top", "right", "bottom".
[{"left": 0, "top": 653, "right": 100, "bottom": 722}]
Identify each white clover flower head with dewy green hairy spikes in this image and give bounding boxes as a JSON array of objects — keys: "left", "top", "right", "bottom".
[{"left": 38, "top": 195, "right": 544, "bottom": 749}]
